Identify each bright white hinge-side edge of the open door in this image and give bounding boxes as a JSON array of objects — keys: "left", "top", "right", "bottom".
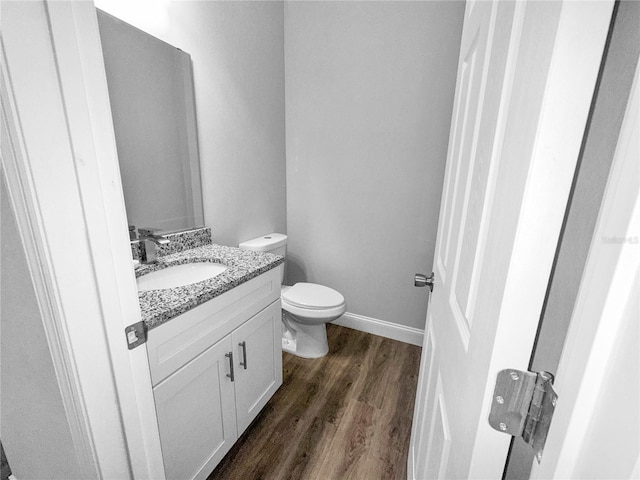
[{"left": 469, "top": 1, "right": 614, "bottom": 478}]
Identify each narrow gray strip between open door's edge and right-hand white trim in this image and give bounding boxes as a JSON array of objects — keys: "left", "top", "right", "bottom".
[{"left": 504, "top": 2, "right": 640, "bottom": 479}]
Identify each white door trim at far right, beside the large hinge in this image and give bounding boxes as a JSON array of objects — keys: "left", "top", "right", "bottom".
[{"left": 531, "top": 62, "right": 640, "bottom": 479}]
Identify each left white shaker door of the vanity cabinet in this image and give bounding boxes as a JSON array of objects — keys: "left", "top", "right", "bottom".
[{"left": 153, "top": 336, "right": 237, "bottom": 480}]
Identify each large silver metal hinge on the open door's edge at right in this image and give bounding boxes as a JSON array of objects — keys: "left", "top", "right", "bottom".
[{"left": 489, "top": 369, "right": 558, "bottom": 463}]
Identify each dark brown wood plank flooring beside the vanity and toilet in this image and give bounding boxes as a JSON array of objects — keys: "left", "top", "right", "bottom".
[{"left": 208, "top": 324, "right": 421, "bottom": 480}]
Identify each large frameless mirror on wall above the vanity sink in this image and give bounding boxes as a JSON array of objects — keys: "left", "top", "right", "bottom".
[{"left": 97, "top": 10, "right": 204, "bottom": 235}]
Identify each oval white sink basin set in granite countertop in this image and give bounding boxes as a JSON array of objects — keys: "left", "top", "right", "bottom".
[{"left": 136, "top": 262, "right": 228, "bottom": 291}]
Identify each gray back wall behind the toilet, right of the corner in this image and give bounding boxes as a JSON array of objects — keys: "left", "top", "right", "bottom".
[{"left": 285, "top": 1, "right": 464, "bottom": 328}]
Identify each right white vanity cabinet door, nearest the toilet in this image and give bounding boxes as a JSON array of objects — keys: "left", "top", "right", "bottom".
[{"left": 231, "top": 300, "right": 282, "bottom": 435}]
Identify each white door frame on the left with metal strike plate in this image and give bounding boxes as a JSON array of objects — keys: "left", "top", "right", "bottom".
[{"left": 1, "top": 0, "right": 165, "bottom": 479}]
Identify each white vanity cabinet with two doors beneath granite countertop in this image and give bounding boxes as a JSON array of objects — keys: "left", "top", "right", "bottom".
[{"left": 147, "top": 267, "right": 282, "bottom": 479}]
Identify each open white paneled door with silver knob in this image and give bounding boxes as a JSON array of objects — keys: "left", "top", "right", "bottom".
[{"left": 408, "top": 1, "right": 613, "bottom": 479}]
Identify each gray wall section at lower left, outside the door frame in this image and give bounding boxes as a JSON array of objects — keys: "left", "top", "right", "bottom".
[{"left": 0, "top": 178, "right": 82, "bottom": 479}]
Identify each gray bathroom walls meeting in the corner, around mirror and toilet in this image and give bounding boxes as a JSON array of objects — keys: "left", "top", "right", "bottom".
[{"left": 97, "top": 1, "right": 464, "bottom": 328}]
